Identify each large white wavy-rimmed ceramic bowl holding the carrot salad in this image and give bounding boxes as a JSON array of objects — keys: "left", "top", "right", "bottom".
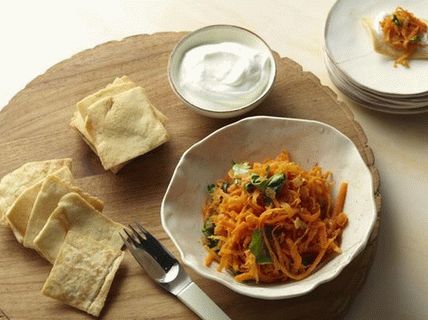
[{"left": 161, "top": 116, "right": 376, "bottom": 300}]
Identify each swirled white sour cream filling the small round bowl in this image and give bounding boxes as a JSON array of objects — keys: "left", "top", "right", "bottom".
[{"left": 179, "top": 42, "right": 271, "bottom": 111}]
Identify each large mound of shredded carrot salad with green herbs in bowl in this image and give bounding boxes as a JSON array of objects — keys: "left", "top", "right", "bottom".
[{"left": 202, "top": 151, "right": 348, "bottom": 283}]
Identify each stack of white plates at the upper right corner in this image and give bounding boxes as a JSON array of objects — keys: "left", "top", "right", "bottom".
[{"left": 324, "top": 0, "right": 428, "bottom": 114}]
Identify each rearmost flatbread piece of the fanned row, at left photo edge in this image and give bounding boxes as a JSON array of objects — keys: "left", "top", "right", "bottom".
[{"left": 0, "top": 159, "right": 71, "bottom": 225}]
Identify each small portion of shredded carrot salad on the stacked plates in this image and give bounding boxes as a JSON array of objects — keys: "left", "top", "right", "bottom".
[{"left": 380, "top": 7, "right": 427, "bottom": 67}]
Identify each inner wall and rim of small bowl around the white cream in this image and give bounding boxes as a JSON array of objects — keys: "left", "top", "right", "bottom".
[{"left": 168, "top": 25, "right": 276, "bottom": 113}]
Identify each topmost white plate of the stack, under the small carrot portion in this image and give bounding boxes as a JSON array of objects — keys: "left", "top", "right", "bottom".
[{"left": 324, "top": 0, "right": 428, "bottom": 96}]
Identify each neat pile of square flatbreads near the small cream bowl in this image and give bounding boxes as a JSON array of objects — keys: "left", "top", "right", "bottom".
[{"left": 70, "top": 76, "right": 169, "bottom": 173}]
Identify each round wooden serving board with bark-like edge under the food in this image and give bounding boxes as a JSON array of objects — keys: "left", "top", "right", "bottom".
[{"left": 0, "top": 33, "right": 380, "bottom": 320}]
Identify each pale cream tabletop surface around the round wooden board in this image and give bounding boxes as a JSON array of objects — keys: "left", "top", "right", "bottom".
[{"left": 0, "top": 0, "right": 428, "bottom": 320}]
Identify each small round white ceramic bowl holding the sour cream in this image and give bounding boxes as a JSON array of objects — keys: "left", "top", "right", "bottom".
[{"left": 168, "top": 25, "right": 276, "bottom": 118}]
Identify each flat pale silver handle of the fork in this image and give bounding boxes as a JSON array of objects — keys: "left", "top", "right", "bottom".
[{"left": 177, "top": 282, "right": 230, "bottom": 320}]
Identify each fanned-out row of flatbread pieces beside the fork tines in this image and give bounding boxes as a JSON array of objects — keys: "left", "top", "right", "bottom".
[{"left": 0, "top": 159, "right": 124, "bottom": 316}]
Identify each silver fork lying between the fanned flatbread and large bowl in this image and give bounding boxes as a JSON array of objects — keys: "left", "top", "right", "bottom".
[{"left": 120, "top": 223, "right": 230, "bottom": 320}]
